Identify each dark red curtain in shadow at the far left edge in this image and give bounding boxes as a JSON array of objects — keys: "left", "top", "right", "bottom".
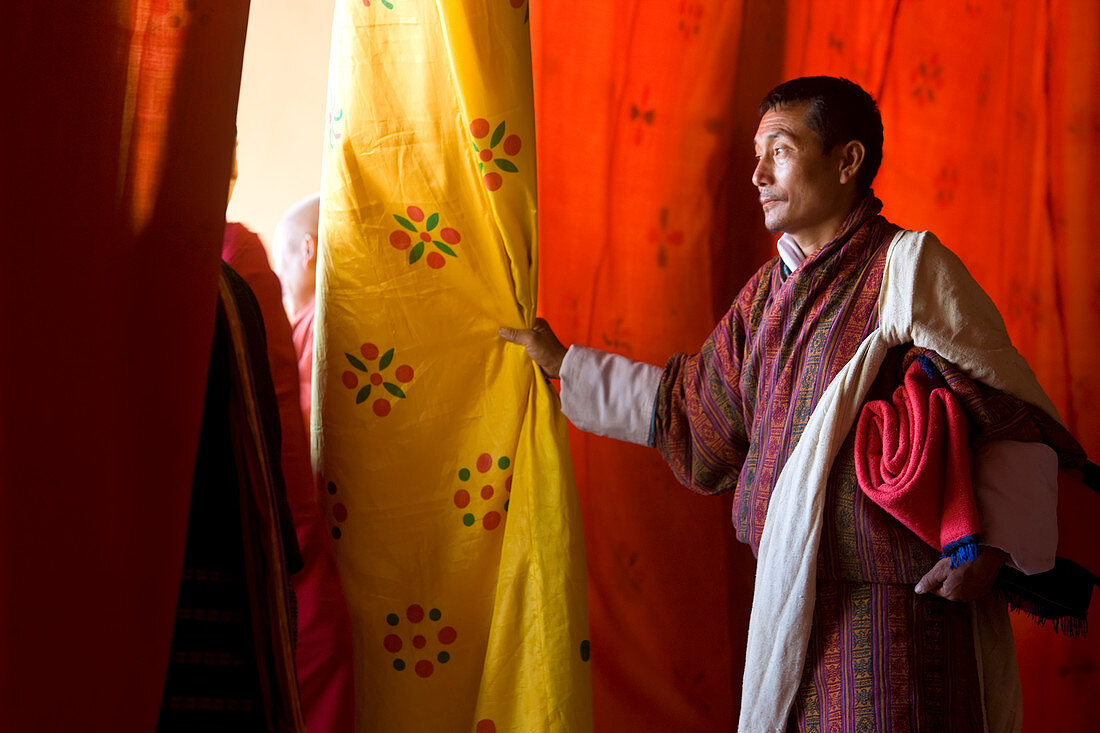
[{"left": 0, "top": 0, "right": 248, "bottom": 732}]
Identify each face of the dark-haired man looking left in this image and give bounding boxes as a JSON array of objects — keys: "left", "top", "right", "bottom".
[{"left": 752, "top": 105, "right": 849, "bottom": 248}]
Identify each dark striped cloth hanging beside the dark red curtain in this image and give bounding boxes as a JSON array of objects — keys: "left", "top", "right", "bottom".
[{"left": 157, "top": 265, "right": 305, "bottom": 733}]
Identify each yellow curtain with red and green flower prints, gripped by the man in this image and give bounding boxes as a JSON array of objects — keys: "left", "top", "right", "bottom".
[{"left": 312, "top": 0, "right": 592, "bottom": 733}]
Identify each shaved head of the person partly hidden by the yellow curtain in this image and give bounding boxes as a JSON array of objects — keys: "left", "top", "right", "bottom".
[{"left": 273, "top": 194, "right": 320, "bottom": 317}]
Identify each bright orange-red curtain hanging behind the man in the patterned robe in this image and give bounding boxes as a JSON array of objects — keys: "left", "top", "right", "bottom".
[{"left": 531, "top": 0, "right": 1100, "bottom": 731}]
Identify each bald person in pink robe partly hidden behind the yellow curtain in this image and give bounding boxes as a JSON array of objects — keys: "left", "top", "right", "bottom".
[{"left": 274, "top": 195, "right": 320, "bottom": 431}]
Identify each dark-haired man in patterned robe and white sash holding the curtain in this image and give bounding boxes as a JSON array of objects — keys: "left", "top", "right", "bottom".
[{"left": 501, "top": 77, "right": 1084, "bottom": 731}]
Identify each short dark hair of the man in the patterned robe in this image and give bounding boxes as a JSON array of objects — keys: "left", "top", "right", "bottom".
[{"left": 760, "top": 76, "right": 882, "bottom": 190}]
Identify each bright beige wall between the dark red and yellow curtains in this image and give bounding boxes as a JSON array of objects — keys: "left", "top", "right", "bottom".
[{"left": 226, "top": 0, "right": 333, "bottom": 251}]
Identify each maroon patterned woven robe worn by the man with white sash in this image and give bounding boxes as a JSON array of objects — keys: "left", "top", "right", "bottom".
[{"left": 653, "top": 194, "right": 1080, "bottom": 732}]
